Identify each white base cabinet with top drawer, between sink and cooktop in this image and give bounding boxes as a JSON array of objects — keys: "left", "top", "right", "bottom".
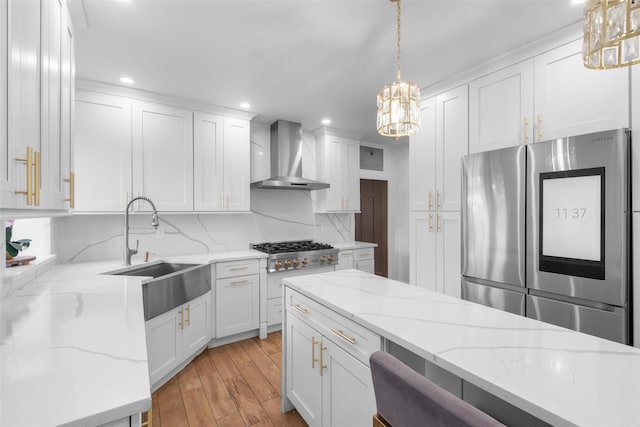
[{"left": 215, "top": 259, "right": 260, "bottom": 338}]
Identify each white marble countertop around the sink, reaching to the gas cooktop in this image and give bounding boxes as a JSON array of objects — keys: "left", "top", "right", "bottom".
[{"left": 0, "top": 250, "right": 267, "bottom": 427}]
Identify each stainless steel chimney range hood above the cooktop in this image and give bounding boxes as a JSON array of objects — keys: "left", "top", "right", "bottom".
[{"left": 251, "top": 120, "right": 329, "bottom": 190}]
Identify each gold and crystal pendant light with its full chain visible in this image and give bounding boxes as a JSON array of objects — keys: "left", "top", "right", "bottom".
[{"left": 377, "top": 0, "right": 420, "bottom": 139}]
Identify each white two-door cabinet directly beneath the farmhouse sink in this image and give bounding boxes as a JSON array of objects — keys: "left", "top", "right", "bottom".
[{"left": 146, "top": 292, "right": 211, "bottom": 386}]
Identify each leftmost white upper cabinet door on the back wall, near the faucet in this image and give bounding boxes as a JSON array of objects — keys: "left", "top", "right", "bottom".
[{"left": 74, "top": 91, "right": 132, "bottom": 212}]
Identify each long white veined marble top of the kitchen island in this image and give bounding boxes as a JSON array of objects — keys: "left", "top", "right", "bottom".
[{"left": 284, "top": 270, "right": 640, "bottom": 427}]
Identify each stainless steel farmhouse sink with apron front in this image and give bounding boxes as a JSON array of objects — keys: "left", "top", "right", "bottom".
[{"left": 103, "top": 262, "right": 211, "bottom": 320}]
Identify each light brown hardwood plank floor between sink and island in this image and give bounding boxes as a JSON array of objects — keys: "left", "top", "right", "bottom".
[{"left": 151, "top": 332, "right": 307, "bottom": 427}]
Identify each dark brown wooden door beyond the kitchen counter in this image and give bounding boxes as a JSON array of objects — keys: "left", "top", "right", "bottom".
[{"left": 356, "top": 179, "right": 389, "bottom": 277}]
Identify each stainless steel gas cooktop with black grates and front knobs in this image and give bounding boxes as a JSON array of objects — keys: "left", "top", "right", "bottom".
[{"left": 251, "top": 240, "right": 339, "bottom": 273}]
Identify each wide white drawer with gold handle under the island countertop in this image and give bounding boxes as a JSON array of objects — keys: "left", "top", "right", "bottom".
[{"left": 285, "top": 288, "right": 381, "bottom": 366}]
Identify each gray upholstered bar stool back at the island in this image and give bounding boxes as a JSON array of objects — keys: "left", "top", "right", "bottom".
[{"left": 370, "top": 351, "right": 504, "bottom": 427}]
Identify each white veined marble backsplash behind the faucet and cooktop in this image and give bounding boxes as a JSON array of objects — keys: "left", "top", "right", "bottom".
[{"left": 51, "top": 189, "right": 354, "bottom": 263}]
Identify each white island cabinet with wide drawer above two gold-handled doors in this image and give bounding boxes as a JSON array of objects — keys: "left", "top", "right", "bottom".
[{"left": 284, "top": 289, "right": 380, "bottom": 427}]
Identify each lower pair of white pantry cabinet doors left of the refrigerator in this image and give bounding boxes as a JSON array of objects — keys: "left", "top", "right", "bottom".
[{"left": 409, "top": 211, "right": 461, "bottom": 298}]
